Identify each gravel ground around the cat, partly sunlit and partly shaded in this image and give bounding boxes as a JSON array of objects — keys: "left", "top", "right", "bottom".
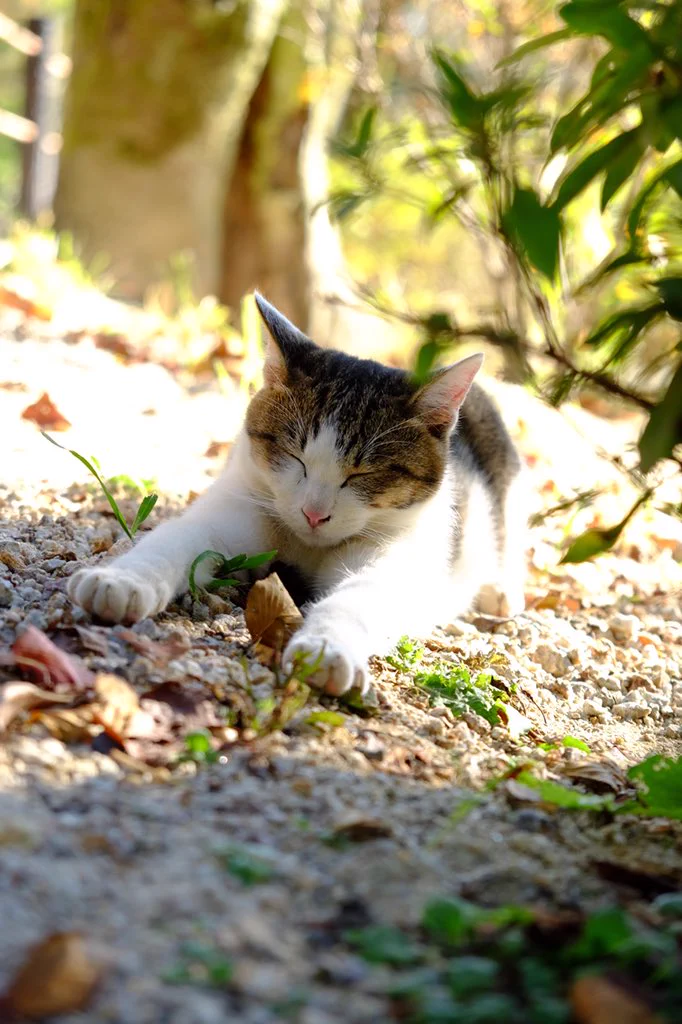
[{"left": 0, "top": 321, "right": 682, "bottom": 1024}]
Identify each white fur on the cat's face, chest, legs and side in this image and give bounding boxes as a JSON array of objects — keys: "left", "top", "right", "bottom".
[{"left": 69, "top": 391, "right": 523, "bottom": 694}]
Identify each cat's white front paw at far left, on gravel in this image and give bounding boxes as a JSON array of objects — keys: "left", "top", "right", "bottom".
[{"left": 68, "top": 565, "right": 173, "bottom": 623}]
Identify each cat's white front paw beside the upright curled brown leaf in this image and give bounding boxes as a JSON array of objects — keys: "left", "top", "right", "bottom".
[{"left": 282, "top": 627, "right": 370, "bottom": 696}]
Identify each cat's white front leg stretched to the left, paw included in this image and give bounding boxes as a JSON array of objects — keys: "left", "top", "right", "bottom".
[{"left": 69, "top": 448, "right": 267, "bottom": 623}]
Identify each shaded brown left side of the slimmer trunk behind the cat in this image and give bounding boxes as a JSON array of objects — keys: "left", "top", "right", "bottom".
[{"left": 219, "top": 4, "right": 308, "bottom": 329}]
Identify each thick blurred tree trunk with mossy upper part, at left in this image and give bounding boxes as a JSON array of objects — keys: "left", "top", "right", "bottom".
[{"left": 55, "top": 0, "right": 286, "bottom": 298}]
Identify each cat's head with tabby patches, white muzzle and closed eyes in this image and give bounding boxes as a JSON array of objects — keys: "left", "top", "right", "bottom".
[{"left": 246, "top": 295, "right": 482, "bottom": 547}]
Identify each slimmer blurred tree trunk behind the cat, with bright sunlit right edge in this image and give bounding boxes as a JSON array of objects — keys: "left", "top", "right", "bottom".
[{"left": 220, "top": 0, "right": 380, "bottom": 348}]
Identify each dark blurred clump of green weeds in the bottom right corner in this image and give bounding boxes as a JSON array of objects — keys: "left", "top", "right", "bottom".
[{"left": 344, "top": 894, "right": 682, "bottom": 1024}]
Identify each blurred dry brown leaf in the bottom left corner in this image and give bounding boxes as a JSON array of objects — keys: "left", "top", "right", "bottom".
[{"left": 3, "top": 932, "right": 101, "bottom": 1020}]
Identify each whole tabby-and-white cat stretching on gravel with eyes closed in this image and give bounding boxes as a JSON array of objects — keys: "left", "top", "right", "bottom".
[{"left": 69, "top": 295, "right": 526, "bottom": 695}]
